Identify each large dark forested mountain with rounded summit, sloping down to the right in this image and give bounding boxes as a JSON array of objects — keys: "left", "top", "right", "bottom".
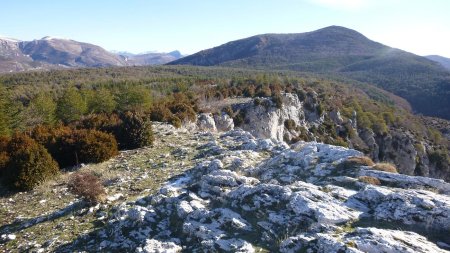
[{"left": 169, "top": 26, "right": 450, "bottom": 119}]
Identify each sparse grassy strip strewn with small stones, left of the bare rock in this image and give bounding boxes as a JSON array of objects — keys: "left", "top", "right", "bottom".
[{"left": 0, "top": 122, "right": 209, "bottom": 252}]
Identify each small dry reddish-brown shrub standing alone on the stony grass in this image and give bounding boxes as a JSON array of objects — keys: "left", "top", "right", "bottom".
[{"left": 68, "top": 172, "right": 106, "bottom": 204}]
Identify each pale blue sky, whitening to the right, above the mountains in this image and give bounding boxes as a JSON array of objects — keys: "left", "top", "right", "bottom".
[{"left": 0, "top": 0, "right": 450, "bottom": 57}]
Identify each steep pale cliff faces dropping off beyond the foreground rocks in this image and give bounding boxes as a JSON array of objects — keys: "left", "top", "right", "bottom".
[{"left": 202, "top": 92, "right": 450, "bottom": 180}]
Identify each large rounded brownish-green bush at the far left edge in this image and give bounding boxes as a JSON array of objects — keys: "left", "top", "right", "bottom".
[{"left": 4, "top": 134, "right": 58, "bottom": 190}]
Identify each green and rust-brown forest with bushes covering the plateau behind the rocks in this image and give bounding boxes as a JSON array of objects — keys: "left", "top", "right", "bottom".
[{"left": 0, "top": 66, "right": 449, "bottom": 190}]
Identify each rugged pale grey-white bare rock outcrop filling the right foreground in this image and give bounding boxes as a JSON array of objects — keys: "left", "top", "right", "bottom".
[{"left": 59, "top": 129, "right": 450, "bottom": 252}]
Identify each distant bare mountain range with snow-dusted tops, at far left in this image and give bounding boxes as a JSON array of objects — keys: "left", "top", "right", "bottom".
[{"left": 0, "top": 37, "right": 182, "bottom": 73}]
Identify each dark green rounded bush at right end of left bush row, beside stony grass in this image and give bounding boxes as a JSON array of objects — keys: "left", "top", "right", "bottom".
[{"left": 117, "top": 112, "right": 154, "bottom": 149}]
